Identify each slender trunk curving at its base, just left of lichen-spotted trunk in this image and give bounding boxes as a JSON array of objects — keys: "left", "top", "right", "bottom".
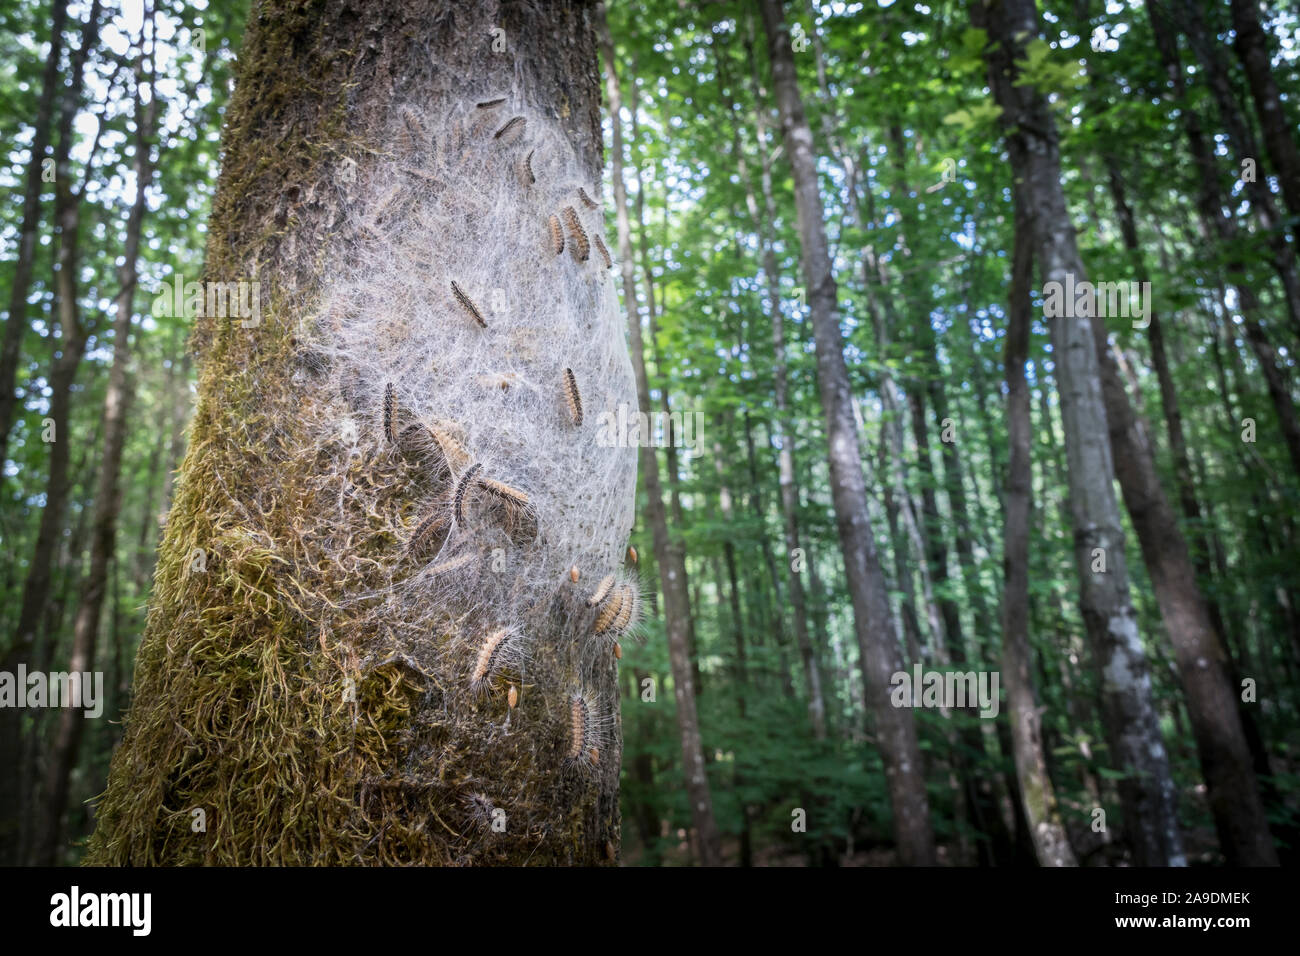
[{"left": 1002, "top": 191, "right": 1076, "bottom": 866}]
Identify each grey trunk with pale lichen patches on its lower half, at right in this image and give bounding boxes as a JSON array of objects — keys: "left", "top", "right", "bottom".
[{"left": 971, "top": 0, "right": 1186, "bottom": 866}]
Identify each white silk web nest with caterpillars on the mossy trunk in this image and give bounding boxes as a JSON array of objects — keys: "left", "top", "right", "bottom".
[{"left": 295, "top": 98, "right": 640, "bottom": 728}]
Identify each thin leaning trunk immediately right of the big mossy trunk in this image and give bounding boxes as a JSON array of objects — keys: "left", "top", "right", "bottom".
[{"left": 595, "top": 3, "right": 722, "bottom": 866}]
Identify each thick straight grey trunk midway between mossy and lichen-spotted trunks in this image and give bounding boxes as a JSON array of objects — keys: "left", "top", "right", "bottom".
[{"left": 761, "top": 0, "right": 935, "bottom": 865}]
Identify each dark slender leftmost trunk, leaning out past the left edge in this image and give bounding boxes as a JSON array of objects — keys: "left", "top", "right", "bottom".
[{"left": 0, "top": 0, "right": 68, "bottom": 463}]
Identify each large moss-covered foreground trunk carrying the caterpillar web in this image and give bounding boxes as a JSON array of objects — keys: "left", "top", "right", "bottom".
[{"left": 87, "top": 0, "right": 636, "bottom": 865}]
